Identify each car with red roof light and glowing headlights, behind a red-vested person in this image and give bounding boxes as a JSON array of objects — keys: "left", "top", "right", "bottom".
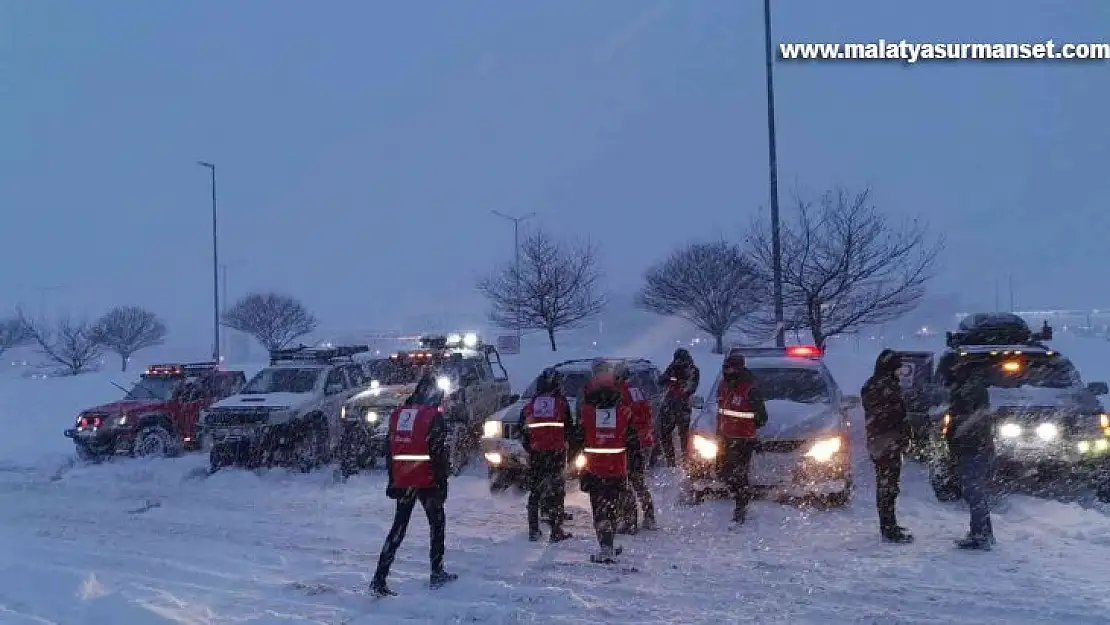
[{"left": 680, "top": 345, "right": 858, "bottom": 505}]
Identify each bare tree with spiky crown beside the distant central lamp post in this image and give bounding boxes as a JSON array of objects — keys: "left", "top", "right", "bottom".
[{"left": 477, "top": 230, "right": 606, "bottom": 352}]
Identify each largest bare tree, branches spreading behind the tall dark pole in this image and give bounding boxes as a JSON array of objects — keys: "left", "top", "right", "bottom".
[{"left": 750, "top": 188, "right": 944, "bottom": 347}]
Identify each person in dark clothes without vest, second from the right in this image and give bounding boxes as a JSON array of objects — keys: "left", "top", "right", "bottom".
[{"left": 860, "top": 350, "right": 914, "bottom": 543}]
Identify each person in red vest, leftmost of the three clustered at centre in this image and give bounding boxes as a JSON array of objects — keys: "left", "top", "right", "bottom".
[{"left": 521, "top": 369, "right": 574, "bottom": 543}]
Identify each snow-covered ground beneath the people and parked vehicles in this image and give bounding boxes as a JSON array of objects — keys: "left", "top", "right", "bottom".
[{"left": 0, "top": 341, "right": 1110, "bottom": 625}]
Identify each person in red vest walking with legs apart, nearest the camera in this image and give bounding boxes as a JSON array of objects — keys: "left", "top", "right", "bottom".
[{"left": 370, "top": 373, "right": 458, "bottom": 596}]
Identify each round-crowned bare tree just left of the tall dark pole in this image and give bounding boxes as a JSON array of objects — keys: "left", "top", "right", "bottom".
[{"left": 636, "top": 241, "right": 764, "bottom": 354}]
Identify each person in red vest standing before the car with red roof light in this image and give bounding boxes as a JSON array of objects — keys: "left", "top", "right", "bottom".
[{"left": 717, "top": 352, "right": 767, "bottom": 524}]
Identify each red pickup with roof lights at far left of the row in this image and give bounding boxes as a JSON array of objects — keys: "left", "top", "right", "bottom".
[{"left": 64, "top": 363, "right": 246, "bottom": 461}]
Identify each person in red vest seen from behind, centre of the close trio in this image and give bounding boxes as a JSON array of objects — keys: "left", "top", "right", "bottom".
[{"left": 577, "top": 360, "right": 639, "bottom": 563}]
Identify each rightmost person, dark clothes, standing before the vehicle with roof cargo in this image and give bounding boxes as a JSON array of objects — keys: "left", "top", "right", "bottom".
[{"left": 947, "top": 361, "right": 995, "bottom": 551}]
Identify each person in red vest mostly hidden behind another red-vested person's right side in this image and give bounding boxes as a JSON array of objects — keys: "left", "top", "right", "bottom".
[{"left": 616, "top": 363, "right": 656, "bottom": 534}]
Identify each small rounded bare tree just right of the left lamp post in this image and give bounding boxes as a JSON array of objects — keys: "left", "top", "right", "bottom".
[{"left": 222, "top": 293, "right": 316, "bottom": 352}]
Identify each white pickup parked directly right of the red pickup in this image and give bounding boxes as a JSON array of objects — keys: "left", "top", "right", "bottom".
[{"left": 200, "top": 345, "right": 370, "bottom": 471}]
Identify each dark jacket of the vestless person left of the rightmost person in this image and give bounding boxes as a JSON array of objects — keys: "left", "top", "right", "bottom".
[{"left": 859, "top": 350, "right": 909, "bottom": 460}]
